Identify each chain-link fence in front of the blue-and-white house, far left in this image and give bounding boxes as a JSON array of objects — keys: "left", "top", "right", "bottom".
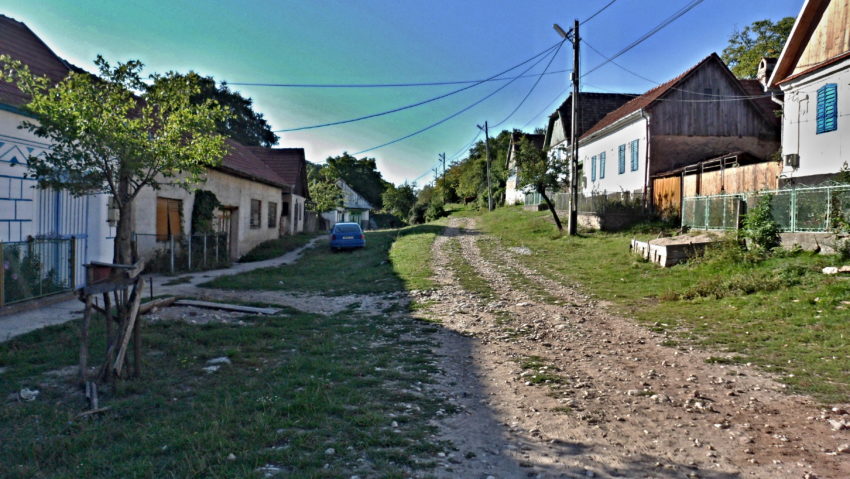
[{"left": 0, "top": 239, "right": 76, "bottom": 306}]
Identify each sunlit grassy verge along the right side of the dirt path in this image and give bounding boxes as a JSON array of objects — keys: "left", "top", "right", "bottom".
[{"left": 479, "top": 208, "right": 850, "bottom": 402}]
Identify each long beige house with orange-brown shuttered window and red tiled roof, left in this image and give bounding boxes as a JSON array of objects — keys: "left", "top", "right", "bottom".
[{"left": 133, "top": 140, "right": 285, "bottom": 260}]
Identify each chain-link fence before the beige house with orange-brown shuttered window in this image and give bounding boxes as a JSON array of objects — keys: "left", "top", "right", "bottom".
[{"left": 133, "top": 233, "right": 231, "bottom": 274}]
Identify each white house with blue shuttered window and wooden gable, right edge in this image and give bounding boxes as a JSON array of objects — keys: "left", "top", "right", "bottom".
[{"left": 768, "top": 0, "right": 850, "bottom": 184}]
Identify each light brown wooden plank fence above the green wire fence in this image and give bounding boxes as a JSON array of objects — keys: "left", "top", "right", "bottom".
[{"left": 682, "top": 162, "right": 782, "bottom": 197}]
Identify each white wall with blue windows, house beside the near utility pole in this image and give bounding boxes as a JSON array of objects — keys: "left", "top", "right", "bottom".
[{"left": 578, "top": 118, "right": 654, "bottom": 195}]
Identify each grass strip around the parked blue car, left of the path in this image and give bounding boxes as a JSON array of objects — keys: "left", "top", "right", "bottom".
[{"left": 202, "top": 225, "right": 442, "bottom": 295}]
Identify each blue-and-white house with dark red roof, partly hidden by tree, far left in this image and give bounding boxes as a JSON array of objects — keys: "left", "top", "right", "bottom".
[{"left": 0, "top": 15, "right": 115, "bottom": 303}]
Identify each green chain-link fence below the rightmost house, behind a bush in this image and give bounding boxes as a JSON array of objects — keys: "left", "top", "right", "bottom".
[{"left": 682, "top": 185, "right": 850, "bottom": 233}]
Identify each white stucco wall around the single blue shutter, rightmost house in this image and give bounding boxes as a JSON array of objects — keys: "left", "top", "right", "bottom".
[{"left": 782, "top": 59, "right": 850, "bottom": 182}]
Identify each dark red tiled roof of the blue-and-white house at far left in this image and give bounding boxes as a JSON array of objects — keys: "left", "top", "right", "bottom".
[{"left": 0, "top": 15, "right": 79, "bottom": 106}]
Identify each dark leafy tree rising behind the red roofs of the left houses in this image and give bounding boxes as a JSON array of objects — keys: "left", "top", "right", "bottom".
[{"left": 184, "top": 72, "right": 278, "bottom": 148}]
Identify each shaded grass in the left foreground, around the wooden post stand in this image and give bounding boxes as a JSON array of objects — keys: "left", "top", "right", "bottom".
[{"left": 0, "top": 304, "right": 451, "bottom": 478}]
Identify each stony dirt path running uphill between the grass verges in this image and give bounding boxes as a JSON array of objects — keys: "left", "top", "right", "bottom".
[{"left": 416, "top": 219, "right": 850, "bottom": 479}]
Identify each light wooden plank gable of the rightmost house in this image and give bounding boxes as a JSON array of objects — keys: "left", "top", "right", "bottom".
[{"left": 793, "top": 0, "right": 850, "bottom": 74}]
